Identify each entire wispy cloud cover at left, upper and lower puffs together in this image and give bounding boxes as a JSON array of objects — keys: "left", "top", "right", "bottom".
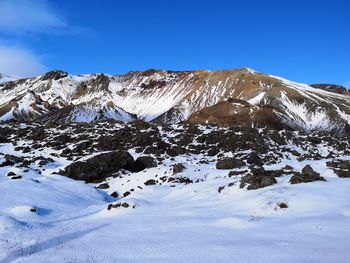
[{"left": 0, "top": 0, "right": 76, "bottom": 77}]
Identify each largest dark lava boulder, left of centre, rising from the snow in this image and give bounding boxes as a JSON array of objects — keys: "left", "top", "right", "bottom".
[{"left": 60, "top": 151, "right": 134, "bottom": 182}]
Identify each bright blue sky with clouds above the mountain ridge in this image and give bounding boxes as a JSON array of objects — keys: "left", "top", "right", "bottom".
[{"left": 0, "top": 0, "right": 350, "bottom": 86}]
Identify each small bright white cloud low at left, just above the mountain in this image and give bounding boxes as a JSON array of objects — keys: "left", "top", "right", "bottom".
[{"left": 0, "top": 46, "right": 47, "bottom": 77}]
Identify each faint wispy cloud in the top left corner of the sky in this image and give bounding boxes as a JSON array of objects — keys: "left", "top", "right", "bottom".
[{"left": 0, "top": 0, "right": 68, "bottom": 34}]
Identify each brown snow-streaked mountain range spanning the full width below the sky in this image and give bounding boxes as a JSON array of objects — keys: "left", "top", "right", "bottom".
[{"left": 0, "top": 68, "right": 350, "bottom": 132}]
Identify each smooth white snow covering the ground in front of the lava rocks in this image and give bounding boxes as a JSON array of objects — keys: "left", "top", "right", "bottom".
[{"left": 0, "top": 124, "right": 350, "bottom": 263}]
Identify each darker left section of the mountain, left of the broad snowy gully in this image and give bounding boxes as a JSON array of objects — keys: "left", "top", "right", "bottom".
[{"left": 0, "top": 71, "right": 135, "bottom": 122}]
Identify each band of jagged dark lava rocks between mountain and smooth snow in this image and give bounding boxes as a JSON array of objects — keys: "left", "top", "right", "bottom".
[{"left": 0, "top": 121, "right": 350, "bottom": 191}]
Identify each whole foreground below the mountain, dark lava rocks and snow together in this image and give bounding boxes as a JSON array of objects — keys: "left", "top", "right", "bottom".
[{"left": 0, "top": 121, "right": 350, "bottom": 262}]
